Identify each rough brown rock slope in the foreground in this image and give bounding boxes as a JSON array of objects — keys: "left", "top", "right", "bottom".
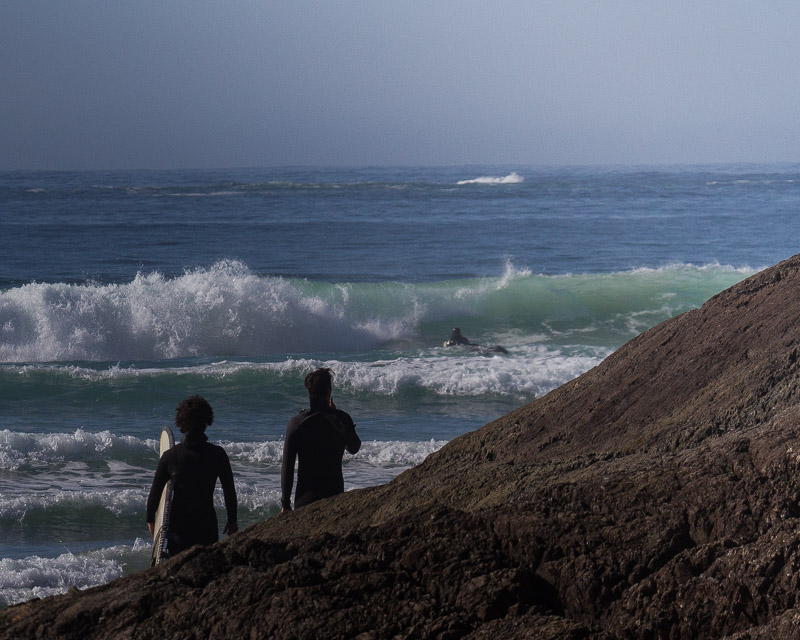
[{"left": 7, "top": 257, "right": 800, "bottom": 640}]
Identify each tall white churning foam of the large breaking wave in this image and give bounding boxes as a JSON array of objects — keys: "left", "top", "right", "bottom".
[{"left": 0, "top": 261, "right": 407, "bottom": 362}]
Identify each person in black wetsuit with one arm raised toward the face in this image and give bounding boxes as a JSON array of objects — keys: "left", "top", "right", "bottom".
[{"left": 281, "top": 368, "right": 361, "bottom": 513}]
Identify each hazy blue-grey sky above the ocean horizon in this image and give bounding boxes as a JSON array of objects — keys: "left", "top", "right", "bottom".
[{"left": 0, "top": 0, "right": 800, "bottom": 170}]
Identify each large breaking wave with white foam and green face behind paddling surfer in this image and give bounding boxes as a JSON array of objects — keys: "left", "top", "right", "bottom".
[{"left": 0, "top": 261, "right": 751, "bottom": 363}]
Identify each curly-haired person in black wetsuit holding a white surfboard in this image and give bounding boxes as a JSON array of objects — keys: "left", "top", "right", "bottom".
[{"left": 147, "top": 396, "right": 239, "bottom": 556}]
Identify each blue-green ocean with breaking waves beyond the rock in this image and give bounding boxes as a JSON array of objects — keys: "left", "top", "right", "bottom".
[{"left": 0, "top": 165, "right": 800, "bottom": 606}]
